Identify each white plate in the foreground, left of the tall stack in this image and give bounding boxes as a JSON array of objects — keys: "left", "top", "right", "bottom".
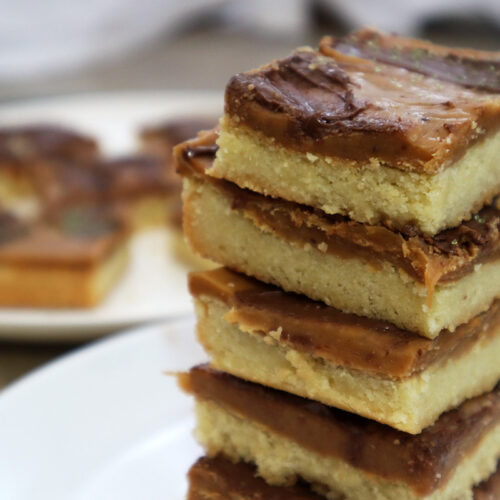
[{"left": 0, "top": 318, "right": 205, "bottom": 500}]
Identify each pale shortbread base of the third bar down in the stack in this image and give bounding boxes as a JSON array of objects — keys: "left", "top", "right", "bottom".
[{"left": 195, "top": 296, "right": 500, "bottom": 434}]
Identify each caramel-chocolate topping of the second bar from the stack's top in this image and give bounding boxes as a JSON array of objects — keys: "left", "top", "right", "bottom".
[{"left": 176, "top": 133, "right": 500, "bottom": 304}]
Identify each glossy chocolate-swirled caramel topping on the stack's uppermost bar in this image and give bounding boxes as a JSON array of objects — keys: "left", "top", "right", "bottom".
[{"left": 226, "top": 32, "right": 500, "bottom": 174}]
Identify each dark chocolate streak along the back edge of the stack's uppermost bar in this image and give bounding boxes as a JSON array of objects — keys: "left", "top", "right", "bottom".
[{"left": 320, "top": 28, "right": 500, "bottom": 92}]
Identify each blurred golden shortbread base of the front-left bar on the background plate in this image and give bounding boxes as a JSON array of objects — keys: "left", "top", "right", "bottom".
[{"left": 0, "top": 244, "right": 129, "bottom": 308}]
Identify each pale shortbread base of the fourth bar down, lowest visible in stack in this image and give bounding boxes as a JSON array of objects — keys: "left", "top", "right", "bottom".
[{"left": 196, "top": 401, "right": 500, "bottom": 500}]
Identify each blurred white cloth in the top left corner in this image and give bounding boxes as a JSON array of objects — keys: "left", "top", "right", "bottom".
[{"left": 0, "top": 0, "right": 221, "bottom": 79}]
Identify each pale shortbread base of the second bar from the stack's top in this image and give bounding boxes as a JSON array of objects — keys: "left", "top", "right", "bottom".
[{"left": 184, "top": 179, "right": 500, "bottom": 338}]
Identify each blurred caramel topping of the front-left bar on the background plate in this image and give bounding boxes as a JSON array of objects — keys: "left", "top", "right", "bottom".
[{"left": 0, "top": 208, "right": 126, "bottom": 267}]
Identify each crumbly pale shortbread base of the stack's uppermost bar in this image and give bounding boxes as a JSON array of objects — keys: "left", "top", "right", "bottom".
[{"left": 208, "top": 118, "right": 500, "bottom": 234}]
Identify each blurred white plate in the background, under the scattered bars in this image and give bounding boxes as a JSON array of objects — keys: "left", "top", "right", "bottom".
[{"left": 0, "top": 92, "right": 222, "bottom": 341}]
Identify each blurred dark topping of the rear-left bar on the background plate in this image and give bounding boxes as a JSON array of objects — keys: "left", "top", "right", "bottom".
[{"left": 0, "top": 125, "right": 97, "bottom": 163}]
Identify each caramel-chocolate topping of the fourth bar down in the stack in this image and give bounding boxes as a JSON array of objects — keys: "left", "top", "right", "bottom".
[{"left": 183, "top": 365, "right": 500, "bottom": 496}]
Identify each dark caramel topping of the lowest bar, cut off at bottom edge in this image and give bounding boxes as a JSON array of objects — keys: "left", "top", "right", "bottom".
[{"left": 187, "top": 455, "right": 500, "bottom": 500}]
